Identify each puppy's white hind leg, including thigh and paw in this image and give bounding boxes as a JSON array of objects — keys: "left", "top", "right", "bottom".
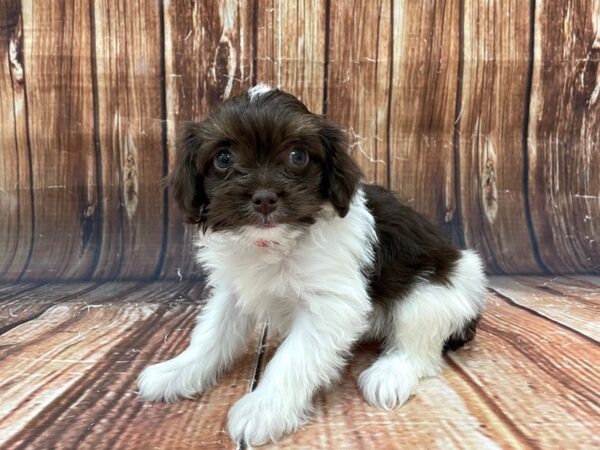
[{"left": 359, "top": 251, "right": 485, "bottom": 409}]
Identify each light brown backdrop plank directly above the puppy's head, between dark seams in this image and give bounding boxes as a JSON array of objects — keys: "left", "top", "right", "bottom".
[{"left": 256, "top": 0, "right": 327, "bottom": 114}]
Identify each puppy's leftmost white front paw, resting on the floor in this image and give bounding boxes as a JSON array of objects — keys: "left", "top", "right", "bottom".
[{"left": 138, "top": 358, "right": 211, "bottom": 402}]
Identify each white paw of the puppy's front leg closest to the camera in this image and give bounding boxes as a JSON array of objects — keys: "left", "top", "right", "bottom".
[{"left": 228, "top": 388, "right": 304, "bottom": 446}]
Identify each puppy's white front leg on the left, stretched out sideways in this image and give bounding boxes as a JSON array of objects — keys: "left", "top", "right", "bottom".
[{"left": 138, "top": 292, "right": 254, "bottom": 401}]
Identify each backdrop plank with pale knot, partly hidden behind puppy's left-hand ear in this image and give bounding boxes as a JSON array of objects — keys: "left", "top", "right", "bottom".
[{"left": 161, "top": 0, "right": 253, "bottom": 278}]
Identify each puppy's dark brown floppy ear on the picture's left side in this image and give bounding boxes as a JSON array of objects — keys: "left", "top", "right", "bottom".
[{"left": 167, "top": 122, "right": 207, "bottom": 224}]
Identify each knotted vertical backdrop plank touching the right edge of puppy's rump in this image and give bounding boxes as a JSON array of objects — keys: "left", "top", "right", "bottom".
[{"left": 458, "top": 0, "right": 540, "bottom": 273}]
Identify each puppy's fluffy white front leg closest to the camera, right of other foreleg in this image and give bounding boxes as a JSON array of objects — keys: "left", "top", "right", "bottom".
[{"left": 228, "top": 298, "right": 368, "bottom": 445}]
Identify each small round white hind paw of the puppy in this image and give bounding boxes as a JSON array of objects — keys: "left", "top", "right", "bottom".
[{"left": 358, "top": 360, "right": 418, "bottom": 410}]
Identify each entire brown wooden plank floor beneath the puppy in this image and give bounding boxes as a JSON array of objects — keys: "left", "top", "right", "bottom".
[{"left": 0, "top": 276, "right": 600, "bottom": 449}]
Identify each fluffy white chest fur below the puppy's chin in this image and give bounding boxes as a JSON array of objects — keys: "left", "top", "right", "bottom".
[{"left": 197, "top": 192, "right": 376, "bottom": 320}]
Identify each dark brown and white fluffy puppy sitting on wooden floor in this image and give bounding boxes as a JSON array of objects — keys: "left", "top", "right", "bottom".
[{"left": 139, "top": 85, "right": 485, "bottom": 445}]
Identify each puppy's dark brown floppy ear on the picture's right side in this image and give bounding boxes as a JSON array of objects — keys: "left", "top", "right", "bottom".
[{"left": 321, "top": 119, "right": 362, "bottom": 217}]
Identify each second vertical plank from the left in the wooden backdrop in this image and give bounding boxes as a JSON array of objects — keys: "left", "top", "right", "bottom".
[{"left": 22, "top": 0, "right": 99, "bottom": 279}]
